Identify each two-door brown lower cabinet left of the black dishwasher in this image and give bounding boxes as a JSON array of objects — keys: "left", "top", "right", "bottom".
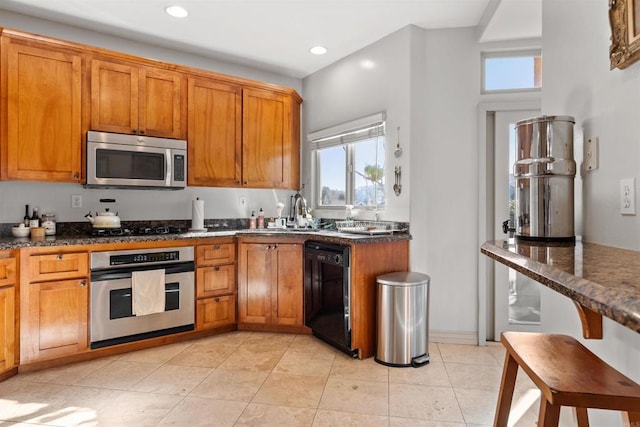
[{"left": 238, "top": 238, "right": 305, "bottom": 331}]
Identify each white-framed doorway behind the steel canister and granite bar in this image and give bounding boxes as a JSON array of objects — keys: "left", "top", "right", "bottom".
[{"left": 478, "top": 100, "right": 540, "bottom": 345}]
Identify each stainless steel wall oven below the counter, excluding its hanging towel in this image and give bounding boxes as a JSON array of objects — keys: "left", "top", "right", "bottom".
[{"left": 90, "top": 246, "right": 195, "bottom": 348}]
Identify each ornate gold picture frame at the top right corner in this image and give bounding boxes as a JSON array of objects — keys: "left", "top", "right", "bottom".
[{"left": 609, "top": 0, "right": 640, "bottom": 70}]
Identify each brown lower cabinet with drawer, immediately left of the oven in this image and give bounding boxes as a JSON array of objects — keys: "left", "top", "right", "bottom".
[{"left": 20, "top": 248, "right": 89, "bottom": 364}]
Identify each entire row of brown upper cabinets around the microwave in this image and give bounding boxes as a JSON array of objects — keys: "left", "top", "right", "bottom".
[{"left": 0, "top": 28, "right": 302, "bottom": 189}]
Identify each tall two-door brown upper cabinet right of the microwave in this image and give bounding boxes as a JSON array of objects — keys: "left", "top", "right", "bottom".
[{"left": 188, "top": 77, "right": 300, "bottom": 189}]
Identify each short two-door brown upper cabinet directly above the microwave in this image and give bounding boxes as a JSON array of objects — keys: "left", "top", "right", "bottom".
[{"left": 91, "top": 59, "right": 186, "bottom": 139}]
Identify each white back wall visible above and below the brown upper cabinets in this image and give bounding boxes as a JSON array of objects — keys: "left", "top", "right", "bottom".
[{"left": 0, "top": 11, "right": 302, "bottom": 223}]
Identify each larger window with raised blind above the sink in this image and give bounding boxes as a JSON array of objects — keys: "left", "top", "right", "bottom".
[{"left": 308, "top": 113, "right": 386, "bottom": 209}]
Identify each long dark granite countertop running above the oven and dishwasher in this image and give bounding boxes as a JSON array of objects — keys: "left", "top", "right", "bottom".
[{"left": 0, "top": 229, "right": 411, "bottom": 250}]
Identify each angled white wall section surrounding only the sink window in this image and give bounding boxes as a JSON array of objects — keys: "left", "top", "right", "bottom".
[{"left": 301, "top": 27, "right": 412, "bottom": 221}]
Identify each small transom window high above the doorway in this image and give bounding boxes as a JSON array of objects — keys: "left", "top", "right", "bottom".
[{"left": 482, "top": 50, "right": 542, "bottom": 93}]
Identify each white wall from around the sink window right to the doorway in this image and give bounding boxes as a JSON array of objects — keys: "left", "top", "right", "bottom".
[{"left": 303, "top": 26, "right": 480, "bottom": 341}]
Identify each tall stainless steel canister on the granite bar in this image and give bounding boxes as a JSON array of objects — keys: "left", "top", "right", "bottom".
[{"left": 513, "top": 116, "right": 576, "bottom": 241}]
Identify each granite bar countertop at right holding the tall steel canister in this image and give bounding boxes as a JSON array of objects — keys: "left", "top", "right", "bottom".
[{"left": 480, "top": 239, "right": 640, "bottom": 332}]
